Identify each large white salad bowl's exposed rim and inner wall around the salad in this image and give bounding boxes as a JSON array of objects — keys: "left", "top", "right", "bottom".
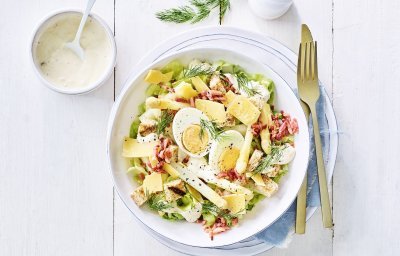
[{"left": 107, "top": 48, "right": 309, "bottom": 247}]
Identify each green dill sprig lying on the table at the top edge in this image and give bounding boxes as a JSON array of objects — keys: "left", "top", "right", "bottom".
[{"left": 156, "top": 0, "right": 230, "bottom": 24}]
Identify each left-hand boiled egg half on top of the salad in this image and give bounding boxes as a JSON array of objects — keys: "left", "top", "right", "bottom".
[{"left": 172, "top": 108, "right": 211, "bottom": 157}]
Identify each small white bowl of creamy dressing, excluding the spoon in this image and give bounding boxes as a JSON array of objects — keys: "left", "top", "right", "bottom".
[{"left": 30, "top": 10, "right": 117, "bottom": 94}]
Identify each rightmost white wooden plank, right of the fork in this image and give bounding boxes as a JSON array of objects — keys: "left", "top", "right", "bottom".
[{"left": 333, "top": 0, "right": 400, "bottom": 256}]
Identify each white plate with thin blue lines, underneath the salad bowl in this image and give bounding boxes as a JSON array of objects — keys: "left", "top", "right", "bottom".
[{"left": 118, "top": 26, "right": 338, "bottom": 256}]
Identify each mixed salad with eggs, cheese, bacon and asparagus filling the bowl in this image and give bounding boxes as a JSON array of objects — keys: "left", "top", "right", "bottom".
[{"left": 122, "top": 59, "right": 298, "bottom": 239}]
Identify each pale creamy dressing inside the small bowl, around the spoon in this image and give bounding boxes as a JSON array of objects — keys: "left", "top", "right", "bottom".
[{"left": 34, "top": 13, "right": 113, "bottom": 89}]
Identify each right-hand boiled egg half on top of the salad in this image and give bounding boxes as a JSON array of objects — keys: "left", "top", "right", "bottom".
[{"left": 208, "top": 130, "right": 244, "bottom": 172}]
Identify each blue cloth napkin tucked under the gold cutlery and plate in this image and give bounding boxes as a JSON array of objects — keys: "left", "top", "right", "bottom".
[{"left": 256, "top": 88, "right": 329, "bottom": 247}]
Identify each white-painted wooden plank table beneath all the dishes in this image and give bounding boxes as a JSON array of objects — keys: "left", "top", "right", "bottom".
[{"left": 0, "top": 0, "right": 400, "bottom": 256}]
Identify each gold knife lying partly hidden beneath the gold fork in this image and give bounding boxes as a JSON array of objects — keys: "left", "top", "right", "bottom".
[{"left": 295, "top": 24, "right": 313, "bottom": 234}]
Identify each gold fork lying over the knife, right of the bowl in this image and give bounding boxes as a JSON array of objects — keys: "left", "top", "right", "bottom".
[{"left": 298, "top": 42, "right": 333, "bottom": 228}]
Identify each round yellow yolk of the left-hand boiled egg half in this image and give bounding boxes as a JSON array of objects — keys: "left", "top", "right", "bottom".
[{"left": 182, "top": 124, "right": 209, "bottom": 154}]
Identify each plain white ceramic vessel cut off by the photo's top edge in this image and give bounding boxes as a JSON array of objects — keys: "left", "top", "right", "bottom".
[{"left": 249, "top": 0, "right": 293, "bottom": 19}]
